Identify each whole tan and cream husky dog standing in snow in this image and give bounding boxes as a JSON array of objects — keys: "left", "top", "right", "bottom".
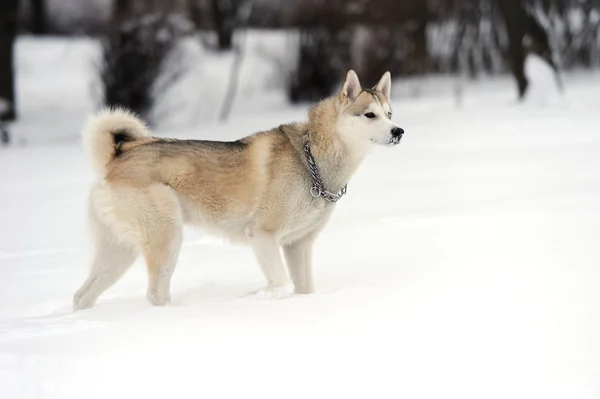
[{"left": 73, "top": 70, "right": 404, "bottom": 309}]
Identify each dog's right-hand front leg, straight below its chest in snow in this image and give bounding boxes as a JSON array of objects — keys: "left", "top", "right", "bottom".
[{"left": 283, "top": 236, "right": 315, "bottom": 294}]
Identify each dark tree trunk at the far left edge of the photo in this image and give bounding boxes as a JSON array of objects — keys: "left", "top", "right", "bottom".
[{"left": 0, "top": 0, "right": 19, "bottom": 121}]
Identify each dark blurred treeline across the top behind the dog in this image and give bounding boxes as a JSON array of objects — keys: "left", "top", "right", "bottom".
[{"left": 0, "top": 0, "right": 600, "bottom": 126}]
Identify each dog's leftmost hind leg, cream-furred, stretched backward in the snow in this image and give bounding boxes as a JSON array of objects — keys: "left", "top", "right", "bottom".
[{"left": 73, "top": 216, "right": 138, "bottom": 310}]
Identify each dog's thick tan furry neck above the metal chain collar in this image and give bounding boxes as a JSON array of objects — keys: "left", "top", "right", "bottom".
[{"left": 306, "top": 97, "right": 367, "bottom": 193}]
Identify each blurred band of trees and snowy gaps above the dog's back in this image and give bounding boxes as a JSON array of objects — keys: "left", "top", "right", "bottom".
[{"left": 0, "top": 0, "right": 600, "bottom": 144}]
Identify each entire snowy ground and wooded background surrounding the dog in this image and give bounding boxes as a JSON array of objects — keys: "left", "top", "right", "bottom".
[{"left": 0, "top": 0, "right": 600, "bottom": 399}]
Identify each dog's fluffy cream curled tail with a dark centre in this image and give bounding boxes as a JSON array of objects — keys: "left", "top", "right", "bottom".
[{"left": 83, "top": 108, "right": 151, "bottom": 175}]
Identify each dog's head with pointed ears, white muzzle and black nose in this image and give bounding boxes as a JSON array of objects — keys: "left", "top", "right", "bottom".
[{"left": 337, "top": 70, "right": 404, "bottom": 151}]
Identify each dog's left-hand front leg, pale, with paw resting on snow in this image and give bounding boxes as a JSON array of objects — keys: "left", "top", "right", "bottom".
[{"left": 252, "top": 234, "right": 292, "bottom": 298}]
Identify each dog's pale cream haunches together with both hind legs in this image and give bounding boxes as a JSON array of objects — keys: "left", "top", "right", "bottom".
[{"left": 73, "top": 182, "right": 183, "bottom": 310}]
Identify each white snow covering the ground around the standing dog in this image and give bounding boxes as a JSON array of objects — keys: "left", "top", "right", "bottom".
[{"left": 0, "top": 37, "right": 600, "bottom": 399}]
